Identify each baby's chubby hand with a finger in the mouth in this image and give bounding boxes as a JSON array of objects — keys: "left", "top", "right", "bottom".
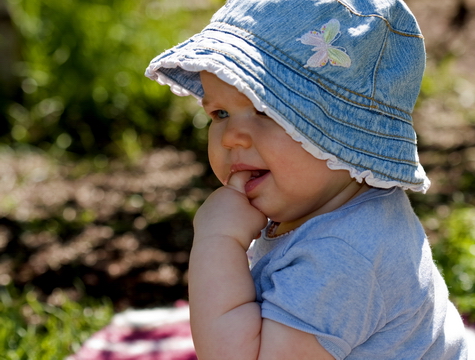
[{"left": 193, "top": 171, "right": 267, "bottom": 250}]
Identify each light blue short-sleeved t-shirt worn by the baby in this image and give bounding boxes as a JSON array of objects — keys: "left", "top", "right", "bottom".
[{"left": 248, "top": 188, "right": 468, "bottom": 360}]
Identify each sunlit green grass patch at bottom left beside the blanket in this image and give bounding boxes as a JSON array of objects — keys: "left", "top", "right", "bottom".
[{"left": 0, "top": 286, "right": 113, "bottom": 360}]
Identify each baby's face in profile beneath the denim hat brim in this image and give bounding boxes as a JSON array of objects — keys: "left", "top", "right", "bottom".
[{"left": 201, "top": 72, "right": 360, "bottom": 230}]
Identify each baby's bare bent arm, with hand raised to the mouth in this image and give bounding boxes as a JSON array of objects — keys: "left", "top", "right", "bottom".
[{"left": 189, "top": 172, "right": 333, "bottom": 360}]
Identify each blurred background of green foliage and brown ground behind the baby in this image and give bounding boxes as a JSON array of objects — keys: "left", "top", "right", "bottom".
[{"left": 0, "top": 0, "right": 475, "bottom": 359}]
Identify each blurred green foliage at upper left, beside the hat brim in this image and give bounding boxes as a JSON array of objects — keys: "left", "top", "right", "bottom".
[{"left": 0, "top": 0, "right": 220, "bottom": 158}]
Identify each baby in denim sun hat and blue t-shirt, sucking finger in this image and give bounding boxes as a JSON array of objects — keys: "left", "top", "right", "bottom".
[{"left": 146, "top": 0, "right": 467, "bottom": 360}]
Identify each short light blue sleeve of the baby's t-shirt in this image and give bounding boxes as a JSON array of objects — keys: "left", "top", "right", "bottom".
[{"left": 258, "top": 238, "right": 385, "bottom": 359}]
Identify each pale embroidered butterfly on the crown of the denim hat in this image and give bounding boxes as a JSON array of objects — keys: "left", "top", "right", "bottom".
[{"left": 297, "top": 19, "right": 351, "bottom": 67}]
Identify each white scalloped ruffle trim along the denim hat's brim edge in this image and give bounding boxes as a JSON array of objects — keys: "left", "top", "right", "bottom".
[{"left": 145, "top": 59, "right": 430, "bottom": 193}]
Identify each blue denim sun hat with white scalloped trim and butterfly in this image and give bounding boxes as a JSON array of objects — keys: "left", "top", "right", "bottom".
[{"left": 146, "top": 0, "right": 430, "bottom": 192}]
